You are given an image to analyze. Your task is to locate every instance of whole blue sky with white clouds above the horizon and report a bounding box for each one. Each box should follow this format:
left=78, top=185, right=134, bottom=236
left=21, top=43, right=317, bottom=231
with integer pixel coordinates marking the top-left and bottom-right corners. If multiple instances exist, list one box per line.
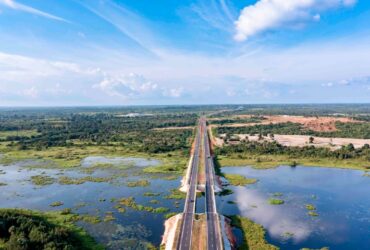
left=0, top=0, right=370, bottom=106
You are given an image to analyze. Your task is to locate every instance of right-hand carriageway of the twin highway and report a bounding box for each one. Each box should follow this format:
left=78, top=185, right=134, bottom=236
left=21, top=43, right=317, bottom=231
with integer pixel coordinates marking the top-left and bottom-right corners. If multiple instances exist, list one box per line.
left=201, top=119, right=223, bottom=250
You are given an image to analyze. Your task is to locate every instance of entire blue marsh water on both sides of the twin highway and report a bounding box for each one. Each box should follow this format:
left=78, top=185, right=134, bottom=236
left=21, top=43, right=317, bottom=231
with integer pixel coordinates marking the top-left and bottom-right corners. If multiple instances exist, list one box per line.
left=0, top=156, right=370, bottom=250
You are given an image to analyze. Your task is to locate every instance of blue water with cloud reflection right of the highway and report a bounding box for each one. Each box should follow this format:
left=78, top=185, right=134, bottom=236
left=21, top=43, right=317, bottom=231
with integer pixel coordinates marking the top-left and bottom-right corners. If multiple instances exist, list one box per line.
left=217, top=166, right=370, bottom=250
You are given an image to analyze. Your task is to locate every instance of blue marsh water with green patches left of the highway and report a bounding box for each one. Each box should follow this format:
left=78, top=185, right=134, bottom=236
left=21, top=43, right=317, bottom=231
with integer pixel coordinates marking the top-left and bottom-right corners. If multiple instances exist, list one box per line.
left=0, top=156, right=183, bottom=249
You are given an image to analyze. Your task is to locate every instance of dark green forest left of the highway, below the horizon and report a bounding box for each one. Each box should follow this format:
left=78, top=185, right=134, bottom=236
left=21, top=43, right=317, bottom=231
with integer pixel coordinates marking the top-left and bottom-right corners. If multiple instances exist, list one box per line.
left=0, top=113, right=198, bottom=153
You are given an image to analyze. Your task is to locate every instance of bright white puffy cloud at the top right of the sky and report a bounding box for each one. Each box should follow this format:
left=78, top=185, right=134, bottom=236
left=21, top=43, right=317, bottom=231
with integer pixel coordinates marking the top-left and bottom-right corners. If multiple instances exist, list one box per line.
left=234, top=0, right=357, bottom=41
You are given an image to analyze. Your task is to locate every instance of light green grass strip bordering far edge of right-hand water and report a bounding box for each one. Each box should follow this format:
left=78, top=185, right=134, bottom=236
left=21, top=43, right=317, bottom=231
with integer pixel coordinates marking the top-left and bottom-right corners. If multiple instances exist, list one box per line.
left=218, top=153, right=370, bottom=170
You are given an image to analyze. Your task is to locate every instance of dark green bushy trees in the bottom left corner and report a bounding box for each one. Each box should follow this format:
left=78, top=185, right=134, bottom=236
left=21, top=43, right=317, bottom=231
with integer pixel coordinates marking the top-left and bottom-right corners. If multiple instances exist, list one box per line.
left=0, top=209, right=104, bottom=250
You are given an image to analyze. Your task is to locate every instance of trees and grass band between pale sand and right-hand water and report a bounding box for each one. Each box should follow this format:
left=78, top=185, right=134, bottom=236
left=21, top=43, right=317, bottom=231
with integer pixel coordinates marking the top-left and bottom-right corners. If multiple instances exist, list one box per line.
left=215, top=142, right=370, bottom=170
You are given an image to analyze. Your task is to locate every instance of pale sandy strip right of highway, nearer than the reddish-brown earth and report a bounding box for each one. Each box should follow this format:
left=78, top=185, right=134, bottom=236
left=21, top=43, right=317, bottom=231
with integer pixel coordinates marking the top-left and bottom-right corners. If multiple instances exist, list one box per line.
left=221, top=134, right=370, bottom=149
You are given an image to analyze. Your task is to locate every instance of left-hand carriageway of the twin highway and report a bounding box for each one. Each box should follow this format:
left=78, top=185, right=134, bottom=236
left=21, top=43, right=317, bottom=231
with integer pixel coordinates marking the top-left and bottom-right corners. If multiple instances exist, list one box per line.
left=177, top=119, right=202, bottom=250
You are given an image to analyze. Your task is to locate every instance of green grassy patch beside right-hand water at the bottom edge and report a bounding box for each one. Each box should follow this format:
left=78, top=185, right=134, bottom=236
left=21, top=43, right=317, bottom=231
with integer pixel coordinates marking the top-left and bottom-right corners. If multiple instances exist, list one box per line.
left=229, top=215, right=279, bottom=250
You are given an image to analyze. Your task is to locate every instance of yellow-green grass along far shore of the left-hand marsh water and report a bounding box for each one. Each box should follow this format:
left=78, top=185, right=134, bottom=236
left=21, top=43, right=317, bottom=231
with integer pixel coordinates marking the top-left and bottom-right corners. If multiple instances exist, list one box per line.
left=0, top=142, right=188, bottom=175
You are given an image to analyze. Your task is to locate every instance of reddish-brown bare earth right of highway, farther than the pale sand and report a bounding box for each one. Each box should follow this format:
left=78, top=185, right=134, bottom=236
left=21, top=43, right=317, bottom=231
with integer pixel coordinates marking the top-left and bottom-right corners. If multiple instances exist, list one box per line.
left=213, top=115, right=360, bottom=132
